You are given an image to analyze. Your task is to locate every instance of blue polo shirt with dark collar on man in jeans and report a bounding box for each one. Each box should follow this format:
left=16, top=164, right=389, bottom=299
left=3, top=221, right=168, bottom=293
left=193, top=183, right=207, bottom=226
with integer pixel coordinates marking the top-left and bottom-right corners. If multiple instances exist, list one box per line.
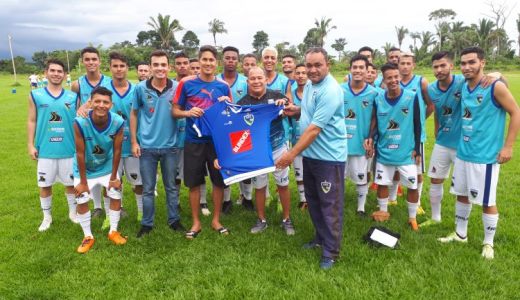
left=132, top=79, right=177, bottom=149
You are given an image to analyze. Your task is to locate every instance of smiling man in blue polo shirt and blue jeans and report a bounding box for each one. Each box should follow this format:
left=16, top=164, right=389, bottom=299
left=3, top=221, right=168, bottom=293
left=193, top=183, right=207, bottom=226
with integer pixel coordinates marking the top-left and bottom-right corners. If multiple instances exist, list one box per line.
left=130, top=50, right=185, bottom=238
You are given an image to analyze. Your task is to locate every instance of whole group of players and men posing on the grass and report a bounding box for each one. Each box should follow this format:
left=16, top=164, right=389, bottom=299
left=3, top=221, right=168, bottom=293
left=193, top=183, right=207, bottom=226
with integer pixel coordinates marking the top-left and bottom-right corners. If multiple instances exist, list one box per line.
left=28, top=41, right=520, bottom=269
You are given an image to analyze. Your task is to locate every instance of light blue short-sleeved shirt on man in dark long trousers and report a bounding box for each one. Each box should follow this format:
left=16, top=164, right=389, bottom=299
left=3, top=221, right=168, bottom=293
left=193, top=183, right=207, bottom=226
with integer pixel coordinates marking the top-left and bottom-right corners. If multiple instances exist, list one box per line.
left=300, top=74, right=347, bottom=162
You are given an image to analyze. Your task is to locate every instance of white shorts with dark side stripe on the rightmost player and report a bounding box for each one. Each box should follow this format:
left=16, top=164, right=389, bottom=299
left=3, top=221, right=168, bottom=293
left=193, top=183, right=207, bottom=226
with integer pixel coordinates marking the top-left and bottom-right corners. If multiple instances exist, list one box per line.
left=451, top=158, right=500, bottom=206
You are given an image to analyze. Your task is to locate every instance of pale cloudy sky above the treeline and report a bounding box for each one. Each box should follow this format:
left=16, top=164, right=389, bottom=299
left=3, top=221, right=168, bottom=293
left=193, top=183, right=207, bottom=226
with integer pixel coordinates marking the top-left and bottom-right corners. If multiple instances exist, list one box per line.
left=0, top=0, right=520, bottom=59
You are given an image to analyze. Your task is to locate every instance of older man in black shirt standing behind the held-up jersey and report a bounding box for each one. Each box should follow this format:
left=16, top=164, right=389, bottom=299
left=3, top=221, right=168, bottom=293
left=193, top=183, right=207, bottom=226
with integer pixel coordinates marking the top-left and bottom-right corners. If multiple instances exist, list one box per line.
left=237, top=67, right=295, bottom=235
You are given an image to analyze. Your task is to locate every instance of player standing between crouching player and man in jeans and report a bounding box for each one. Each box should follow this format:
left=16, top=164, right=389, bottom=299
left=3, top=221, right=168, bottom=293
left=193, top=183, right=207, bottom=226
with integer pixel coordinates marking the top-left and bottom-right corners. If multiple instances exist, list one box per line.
left=102, top=52, right=142, bottom=228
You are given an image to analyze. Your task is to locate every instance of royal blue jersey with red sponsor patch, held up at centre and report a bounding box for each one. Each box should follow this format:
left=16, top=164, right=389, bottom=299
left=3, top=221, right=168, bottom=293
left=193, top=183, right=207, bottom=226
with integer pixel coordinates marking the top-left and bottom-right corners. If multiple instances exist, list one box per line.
left=193, top=101, right=283, bottom=185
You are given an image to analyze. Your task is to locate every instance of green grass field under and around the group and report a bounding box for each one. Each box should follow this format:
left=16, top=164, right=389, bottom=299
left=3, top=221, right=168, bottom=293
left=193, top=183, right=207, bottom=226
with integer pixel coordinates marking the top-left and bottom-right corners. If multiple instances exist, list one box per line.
left=0, top=72, right=520, bottom=299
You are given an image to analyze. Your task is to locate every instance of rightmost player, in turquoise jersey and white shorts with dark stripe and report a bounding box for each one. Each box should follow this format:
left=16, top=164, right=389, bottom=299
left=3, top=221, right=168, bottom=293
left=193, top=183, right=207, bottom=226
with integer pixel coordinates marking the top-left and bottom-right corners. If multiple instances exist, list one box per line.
left=439, top=47, right=520, bottom=259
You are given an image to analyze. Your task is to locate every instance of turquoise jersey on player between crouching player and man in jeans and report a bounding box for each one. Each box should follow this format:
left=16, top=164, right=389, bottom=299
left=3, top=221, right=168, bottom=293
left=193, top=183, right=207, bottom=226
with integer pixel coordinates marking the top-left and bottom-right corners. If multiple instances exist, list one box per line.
left=108, top=81, right=135, bottom=157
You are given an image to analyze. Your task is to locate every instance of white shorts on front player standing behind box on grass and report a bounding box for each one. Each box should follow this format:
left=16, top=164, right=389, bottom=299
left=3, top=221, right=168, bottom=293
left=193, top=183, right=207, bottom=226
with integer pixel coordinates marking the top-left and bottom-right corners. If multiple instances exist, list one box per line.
left=374, top=162, right=417, bottom=190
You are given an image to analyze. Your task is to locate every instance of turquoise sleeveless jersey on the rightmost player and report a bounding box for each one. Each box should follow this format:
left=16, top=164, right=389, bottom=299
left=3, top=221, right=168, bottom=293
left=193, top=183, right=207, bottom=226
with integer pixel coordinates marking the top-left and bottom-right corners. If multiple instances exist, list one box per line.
left=457, top=82, right=506, bottom=164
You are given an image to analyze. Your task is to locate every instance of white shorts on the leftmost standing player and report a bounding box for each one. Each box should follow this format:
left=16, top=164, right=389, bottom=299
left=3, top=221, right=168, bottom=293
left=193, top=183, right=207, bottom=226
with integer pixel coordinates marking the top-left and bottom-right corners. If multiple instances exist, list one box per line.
left=36, top=157, right=74, bottom=187
